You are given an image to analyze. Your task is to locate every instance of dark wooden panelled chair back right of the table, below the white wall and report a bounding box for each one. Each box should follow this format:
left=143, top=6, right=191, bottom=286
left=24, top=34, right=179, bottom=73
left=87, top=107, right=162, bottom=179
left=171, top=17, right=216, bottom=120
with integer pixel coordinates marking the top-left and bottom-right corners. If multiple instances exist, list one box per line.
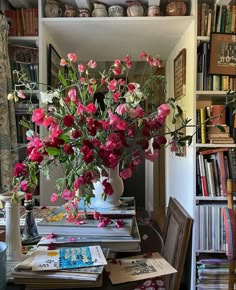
left=163, top=197, right=192, bottom=290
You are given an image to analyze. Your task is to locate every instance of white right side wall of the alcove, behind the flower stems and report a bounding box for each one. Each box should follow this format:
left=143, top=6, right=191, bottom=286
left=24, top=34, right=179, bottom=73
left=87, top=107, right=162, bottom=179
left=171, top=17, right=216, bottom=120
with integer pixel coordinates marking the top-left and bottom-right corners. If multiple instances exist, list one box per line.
left=166, top=23, right=195, bottom=216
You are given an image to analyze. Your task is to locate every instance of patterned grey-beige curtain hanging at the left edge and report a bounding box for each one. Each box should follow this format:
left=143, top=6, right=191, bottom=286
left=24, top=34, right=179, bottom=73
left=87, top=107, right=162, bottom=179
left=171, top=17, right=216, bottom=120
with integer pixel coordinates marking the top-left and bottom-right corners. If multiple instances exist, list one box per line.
left=0, top=14, right=18, bottom=192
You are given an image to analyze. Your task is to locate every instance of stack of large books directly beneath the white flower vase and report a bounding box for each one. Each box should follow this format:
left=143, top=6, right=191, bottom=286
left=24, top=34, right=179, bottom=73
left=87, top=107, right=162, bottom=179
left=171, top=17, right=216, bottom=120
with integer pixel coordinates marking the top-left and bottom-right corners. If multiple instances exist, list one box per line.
left=37, top=197, right=141, bottom=253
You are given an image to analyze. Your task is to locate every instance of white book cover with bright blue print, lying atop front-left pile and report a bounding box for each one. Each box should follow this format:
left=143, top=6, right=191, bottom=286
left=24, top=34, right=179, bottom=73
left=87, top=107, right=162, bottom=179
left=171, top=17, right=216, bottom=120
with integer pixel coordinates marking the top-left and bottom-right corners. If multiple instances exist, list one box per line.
left=32, top=246, right=107, bottom=271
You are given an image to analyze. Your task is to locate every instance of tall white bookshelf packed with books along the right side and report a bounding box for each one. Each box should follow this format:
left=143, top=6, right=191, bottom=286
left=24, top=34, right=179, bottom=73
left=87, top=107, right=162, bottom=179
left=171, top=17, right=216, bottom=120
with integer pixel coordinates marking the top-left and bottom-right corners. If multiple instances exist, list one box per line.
left=193, top=1, right=236, bottom=289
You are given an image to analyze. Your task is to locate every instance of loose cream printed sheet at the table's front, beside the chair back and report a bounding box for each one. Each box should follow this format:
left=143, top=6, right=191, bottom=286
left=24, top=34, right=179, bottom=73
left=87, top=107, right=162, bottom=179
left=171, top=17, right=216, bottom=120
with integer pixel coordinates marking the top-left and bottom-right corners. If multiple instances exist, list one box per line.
left=105, top=252, right=177, bottom=284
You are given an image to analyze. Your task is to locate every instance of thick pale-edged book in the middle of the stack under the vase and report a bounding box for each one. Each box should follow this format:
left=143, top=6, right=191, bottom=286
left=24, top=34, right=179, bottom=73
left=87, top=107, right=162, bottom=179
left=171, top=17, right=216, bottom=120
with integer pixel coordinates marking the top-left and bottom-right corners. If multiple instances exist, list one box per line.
left=37, top=211, right=134, bottom=236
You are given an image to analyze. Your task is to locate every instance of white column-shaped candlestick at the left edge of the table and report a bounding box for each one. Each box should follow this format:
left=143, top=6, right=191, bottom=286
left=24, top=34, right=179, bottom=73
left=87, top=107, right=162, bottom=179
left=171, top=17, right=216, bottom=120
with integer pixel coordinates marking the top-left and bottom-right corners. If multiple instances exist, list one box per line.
left=0, top=192, right=24, bottom=262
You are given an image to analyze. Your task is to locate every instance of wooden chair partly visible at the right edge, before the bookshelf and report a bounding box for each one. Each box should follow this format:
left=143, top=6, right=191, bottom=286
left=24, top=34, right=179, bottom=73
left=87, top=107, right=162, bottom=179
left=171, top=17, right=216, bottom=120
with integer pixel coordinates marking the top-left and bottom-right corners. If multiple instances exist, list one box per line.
left=223, top=179, right=236, bottom=290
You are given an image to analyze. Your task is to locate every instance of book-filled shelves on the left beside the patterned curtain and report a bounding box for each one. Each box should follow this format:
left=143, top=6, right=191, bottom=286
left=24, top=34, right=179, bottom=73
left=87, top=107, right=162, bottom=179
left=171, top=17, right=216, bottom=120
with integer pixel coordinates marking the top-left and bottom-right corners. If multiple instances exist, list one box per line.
left=0, top=1, right=39, bottom=199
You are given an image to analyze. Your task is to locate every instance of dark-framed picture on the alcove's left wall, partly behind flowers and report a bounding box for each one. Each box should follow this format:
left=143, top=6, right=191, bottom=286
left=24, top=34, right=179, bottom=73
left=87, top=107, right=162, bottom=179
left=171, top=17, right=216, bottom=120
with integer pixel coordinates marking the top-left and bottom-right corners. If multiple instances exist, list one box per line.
left=48, top=44, right=61, bottom=90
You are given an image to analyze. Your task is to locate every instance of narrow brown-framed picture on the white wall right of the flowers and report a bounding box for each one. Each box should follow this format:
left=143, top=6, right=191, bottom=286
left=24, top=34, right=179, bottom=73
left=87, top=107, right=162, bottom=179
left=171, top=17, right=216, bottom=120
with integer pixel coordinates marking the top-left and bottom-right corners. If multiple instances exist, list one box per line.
left=174, top=48, right=186, bottom=99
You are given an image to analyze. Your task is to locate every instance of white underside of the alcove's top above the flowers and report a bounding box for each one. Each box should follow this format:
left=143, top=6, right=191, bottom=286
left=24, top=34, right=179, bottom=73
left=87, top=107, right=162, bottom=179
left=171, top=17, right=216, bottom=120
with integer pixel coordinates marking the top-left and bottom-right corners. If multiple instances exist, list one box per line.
left=42, top=16, right=194, bottom=61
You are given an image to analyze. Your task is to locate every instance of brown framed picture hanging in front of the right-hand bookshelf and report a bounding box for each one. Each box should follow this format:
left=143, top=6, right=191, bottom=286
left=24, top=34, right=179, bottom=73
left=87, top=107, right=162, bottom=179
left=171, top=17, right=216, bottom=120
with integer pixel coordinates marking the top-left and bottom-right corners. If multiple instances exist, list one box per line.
left=209, top=32, right=236, bottom=75
